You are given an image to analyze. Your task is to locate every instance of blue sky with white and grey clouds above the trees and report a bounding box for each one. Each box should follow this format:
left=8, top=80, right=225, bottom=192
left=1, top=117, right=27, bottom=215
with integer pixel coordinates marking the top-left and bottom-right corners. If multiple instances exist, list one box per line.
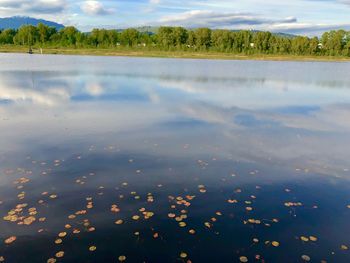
left=0, top=0, right=350, bottom=36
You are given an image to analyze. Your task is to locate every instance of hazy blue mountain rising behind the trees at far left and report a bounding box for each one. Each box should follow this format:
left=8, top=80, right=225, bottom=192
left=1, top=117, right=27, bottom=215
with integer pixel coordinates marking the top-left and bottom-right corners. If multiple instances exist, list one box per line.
left=0, top=16, right=64, bottom=30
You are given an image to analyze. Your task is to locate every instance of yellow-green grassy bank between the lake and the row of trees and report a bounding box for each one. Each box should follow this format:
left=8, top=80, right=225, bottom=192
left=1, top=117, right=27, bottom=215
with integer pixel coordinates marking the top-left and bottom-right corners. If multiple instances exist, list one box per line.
left=0, top=45, right=350, bottom=62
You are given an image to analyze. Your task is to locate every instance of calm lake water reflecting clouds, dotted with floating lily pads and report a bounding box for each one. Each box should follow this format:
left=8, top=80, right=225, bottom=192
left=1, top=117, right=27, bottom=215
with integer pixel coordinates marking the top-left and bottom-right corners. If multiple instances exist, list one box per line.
left=0, top=55, right=350, bottom=263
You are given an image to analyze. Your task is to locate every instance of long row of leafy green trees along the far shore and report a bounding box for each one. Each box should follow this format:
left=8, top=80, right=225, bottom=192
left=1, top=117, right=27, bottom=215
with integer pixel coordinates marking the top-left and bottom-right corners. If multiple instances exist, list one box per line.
left=0, top=24, right=350, bottom=56
